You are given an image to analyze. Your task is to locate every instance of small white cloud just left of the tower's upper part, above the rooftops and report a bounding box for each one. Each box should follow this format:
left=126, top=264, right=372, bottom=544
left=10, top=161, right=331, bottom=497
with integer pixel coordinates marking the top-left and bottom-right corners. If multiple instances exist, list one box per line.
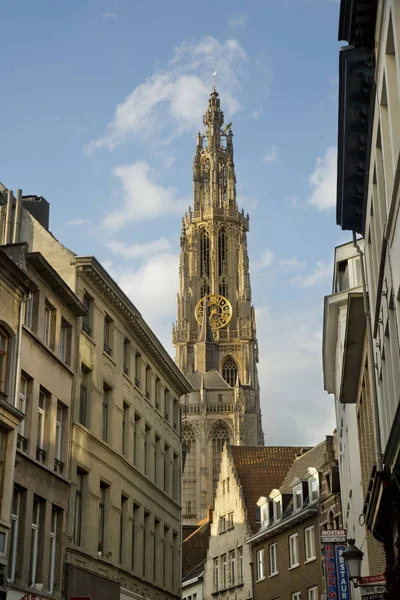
left=102, top=161, right=190, bottom=231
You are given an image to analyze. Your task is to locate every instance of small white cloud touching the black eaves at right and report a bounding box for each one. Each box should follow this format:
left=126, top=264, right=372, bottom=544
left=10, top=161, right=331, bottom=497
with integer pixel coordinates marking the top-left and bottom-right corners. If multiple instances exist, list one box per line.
left=309, top=146, right=337, bottom=211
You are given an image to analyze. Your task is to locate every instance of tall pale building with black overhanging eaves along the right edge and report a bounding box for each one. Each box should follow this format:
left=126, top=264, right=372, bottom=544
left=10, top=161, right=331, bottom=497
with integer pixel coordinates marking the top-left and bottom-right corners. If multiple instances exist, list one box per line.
left=337, top=0, right=400, bottom=598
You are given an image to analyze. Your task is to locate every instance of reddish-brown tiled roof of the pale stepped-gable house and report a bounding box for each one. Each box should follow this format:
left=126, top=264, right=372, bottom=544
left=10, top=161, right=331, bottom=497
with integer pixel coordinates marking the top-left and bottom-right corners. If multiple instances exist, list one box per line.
left=229, top=446, right=302, bottom=533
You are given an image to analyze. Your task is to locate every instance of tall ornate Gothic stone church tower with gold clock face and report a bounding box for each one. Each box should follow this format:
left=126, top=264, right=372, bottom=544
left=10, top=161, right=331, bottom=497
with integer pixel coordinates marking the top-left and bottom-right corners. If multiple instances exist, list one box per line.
left=173, top=88, right=264, bottom=524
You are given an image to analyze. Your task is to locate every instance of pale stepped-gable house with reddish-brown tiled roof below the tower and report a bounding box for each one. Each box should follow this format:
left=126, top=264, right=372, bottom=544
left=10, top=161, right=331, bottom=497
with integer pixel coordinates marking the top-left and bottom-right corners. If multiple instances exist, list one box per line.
left=204, top=446, right=302, bottom=600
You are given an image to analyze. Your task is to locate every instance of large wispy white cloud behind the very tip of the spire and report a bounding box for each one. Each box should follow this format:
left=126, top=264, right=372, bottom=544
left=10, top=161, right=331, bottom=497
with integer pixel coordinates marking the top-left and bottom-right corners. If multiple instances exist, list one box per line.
left=87, top=36, right=246, bottom=152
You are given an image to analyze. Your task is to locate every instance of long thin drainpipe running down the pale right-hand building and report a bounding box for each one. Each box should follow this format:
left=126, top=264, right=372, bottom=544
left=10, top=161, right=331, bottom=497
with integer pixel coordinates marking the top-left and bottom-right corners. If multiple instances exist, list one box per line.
left=353, top=231, right=382, bottom=471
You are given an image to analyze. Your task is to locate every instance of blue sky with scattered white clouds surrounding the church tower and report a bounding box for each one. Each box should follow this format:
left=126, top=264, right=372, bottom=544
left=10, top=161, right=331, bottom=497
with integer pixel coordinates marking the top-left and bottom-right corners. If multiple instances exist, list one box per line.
left=0, top=0, right=349, bottom=444
